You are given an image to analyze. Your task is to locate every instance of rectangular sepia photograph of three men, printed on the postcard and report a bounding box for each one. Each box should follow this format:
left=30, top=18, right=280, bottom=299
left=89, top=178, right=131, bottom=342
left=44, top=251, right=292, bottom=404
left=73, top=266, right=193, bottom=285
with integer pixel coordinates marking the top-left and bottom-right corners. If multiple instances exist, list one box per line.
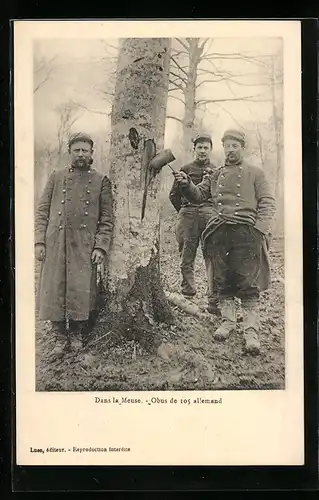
left=32, top=33, right=286, bottom=392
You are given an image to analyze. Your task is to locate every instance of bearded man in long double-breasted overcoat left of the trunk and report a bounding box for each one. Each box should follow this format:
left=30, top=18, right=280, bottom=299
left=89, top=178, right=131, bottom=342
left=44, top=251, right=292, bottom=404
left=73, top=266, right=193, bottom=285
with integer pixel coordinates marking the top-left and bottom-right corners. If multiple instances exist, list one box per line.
left=35, top=133, right=113, bottom=356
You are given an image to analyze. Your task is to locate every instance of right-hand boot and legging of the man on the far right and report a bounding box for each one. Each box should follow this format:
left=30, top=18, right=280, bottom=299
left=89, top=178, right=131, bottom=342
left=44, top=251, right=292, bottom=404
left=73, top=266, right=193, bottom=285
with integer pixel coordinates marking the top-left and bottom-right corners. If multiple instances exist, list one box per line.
left=242, top=301, right=260, bottom=354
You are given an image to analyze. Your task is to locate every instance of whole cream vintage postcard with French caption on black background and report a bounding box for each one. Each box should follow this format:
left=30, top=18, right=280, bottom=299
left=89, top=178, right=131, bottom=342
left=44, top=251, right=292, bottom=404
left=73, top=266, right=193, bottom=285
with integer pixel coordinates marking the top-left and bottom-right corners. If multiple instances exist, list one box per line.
left=14, top=21, right=304, bottom=466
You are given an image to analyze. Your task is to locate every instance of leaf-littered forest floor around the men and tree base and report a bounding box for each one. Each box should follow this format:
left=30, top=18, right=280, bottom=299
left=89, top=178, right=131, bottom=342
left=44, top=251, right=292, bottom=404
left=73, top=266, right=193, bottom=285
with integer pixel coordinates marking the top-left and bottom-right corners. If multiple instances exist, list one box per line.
left=36, top=206, right=285, bottom=391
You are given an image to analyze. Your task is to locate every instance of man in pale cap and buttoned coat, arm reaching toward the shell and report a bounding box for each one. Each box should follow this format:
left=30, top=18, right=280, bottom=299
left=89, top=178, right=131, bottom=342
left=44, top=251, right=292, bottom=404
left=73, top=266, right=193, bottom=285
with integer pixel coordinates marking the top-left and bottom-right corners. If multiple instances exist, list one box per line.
left=175, top=130, right=275, bottom=354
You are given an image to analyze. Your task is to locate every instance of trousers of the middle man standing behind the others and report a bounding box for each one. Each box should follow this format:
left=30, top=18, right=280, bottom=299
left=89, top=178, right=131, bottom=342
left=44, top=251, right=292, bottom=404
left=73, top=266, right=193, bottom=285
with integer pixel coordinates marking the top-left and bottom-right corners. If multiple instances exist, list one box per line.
left=176, top=206, right=218, bottom=297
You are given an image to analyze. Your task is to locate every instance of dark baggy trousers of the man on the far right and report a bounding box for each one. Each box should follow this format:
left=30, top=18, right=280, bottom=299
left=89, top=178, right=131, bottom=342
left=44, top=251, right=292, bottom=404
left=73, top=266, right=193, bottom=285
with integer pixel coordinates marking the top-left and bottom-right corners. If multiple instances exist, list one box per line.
left=207, top=224, right=262, bottom=300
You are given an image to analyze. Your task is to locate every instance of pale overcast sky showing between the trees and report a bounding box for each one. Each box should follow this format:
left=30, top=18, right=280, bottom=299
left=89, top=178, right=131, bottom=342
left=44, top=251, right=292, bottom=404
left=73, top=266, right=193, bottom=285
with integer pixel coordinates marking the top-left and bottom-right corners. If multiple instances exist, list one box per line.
left=34, top=38, right=281, bottom=155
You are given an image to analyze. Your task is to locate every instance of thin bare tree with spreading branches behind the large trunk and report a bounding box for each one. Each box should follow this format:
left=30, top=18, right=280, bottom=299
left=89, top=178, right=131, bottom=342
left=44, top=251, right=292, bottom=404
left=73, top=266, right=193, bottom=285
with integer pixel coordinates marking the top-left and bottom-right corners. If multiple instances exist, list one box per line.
left=168, top=38, right=276, bottom=161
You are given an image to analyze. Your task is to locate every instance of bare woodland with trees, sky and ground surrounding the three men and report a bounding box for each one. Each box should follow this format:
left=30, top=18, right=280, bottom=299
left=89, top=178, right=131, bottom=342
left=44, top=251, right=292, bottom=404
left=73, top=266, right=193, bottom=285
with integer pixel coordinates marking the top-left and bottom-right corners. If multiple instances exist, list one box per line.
left=33, top=38, right=285, bottom=391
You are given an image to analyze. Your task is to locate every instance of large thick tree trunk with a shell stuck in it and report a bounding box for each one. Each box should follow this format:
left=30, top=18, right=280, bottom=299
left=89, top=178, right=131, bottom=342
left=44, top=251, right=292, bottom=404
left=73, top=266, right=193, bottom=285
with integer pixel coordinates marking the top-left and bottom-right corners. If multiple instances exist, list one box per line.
left=105, top=38, right=172, bottom=350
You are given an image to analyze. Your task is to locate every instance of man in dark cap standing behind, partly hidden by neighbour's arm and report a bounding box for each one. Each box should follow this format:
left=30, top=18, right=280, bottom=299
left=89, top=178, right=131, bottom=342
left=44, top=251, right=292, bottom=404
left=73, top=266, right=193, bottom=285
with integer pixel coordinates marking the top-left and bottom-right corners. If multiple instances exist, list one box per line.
left=169, top=134, right=218, bottom=313
